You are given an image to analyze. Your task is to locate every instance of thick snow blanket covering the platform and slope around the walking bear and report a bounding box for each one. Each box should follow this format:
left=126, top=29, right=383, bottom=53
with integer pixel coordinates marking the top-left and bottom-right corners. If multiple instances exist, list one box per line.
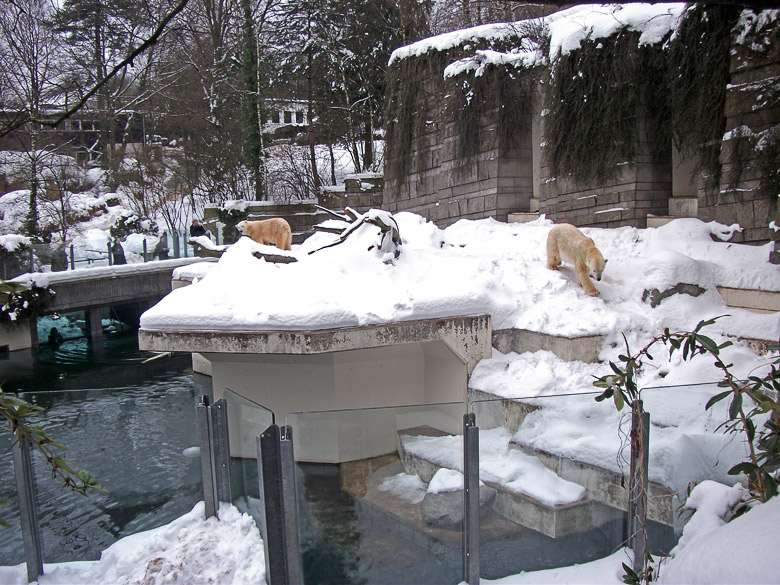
left=141, top=213, right=780, bottom=340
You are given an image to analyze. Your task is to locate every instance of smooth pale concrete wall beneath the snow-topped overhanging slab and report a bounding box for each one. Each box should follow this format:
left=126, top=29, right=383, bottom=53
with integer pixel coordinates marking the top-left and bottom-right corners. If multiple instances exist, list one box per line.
left=204, top=341, right=468, bottom=463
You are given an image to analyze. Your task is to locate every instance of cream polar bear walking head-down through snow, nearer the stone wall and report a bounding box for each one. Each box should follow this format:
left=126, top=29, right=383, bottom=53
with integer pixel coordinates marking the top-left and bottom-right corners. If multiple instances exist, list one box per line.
left=547, top=223, right=607, bottom=297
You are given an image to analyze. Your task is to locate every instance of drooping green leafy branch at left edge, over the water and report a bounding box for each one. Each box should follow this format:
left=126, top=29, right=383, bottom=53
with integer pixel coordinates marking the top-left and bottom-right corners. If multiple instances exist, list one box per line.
left=0, top=390, right=100, bottom=526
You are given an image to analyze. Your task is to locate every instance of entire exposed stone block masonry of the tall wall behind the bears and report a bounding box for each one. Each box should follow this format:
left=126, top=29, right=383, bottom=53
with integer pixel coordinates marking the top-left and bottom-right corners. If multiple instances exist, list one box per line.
left=383, top=17, right=780, bottom=242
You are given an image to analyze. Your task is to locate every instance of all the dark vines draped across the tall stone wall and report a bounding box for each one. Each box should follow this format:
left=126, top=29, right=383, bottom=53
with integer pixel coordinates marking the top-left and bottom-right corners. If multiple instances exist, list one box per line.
left=386, top=4, right=780, bottom=203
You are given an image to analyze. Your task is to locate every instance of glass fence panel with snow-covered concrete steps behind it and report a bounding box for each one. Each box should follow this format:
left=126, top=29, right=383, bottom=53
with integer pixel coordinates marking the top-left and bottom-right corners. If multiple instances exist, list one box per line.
left=469, top=394, right=630, bottom=579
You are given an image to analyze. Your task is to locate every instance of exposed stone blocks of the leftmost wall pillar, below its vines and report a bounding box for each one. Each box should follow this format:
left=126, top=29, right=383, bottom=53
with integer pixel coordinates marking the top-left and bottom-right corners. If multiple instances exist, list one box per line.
left=383, top=69, right=533, bottom=227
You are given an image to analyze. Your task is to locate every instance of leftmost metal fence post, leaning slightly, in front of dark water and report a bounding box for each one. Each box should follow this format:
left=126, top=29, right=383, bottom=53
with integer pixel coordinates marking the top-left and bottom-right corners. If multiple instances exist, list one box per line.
left=13, top=426, right=43, bottom=582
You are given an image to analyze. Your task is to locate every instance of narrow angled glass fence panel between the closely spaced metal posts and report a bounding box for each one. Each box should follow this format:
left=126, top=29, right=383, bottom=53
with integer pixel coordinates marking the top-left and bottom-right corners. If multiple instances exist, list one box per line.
left=223, top=388, right=274, bottom=522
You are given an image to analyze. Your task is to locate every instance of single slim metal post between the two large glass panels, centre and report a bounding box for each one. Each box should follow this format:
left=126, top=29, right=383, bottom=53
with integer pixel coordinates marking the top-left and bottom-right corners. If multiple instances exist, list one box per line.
left=463, top=413, right=479, bottom=585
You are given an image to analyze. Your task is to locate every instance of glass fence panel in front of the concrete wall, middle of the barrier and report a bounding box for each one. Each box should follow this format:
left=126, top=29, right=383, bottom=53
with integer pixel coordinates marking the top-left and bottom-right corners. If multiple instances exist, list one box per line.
left=287, top=403, right=466, bottom=585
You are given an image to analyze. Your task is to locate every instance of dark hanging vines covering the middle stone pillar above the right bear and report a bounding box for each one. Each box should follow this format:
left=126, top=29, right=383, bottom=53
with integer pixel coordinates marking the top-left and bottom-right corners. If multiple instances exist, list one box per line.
left=545, top=30, right=668, bottom=183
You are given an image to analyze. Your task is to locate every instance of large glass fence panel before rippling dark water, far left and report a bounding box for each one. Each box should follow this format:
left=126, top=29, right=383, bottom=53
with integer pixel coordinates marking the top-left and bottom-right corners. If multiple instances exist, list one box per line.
left=0, top=387, right=203, bottom=563
